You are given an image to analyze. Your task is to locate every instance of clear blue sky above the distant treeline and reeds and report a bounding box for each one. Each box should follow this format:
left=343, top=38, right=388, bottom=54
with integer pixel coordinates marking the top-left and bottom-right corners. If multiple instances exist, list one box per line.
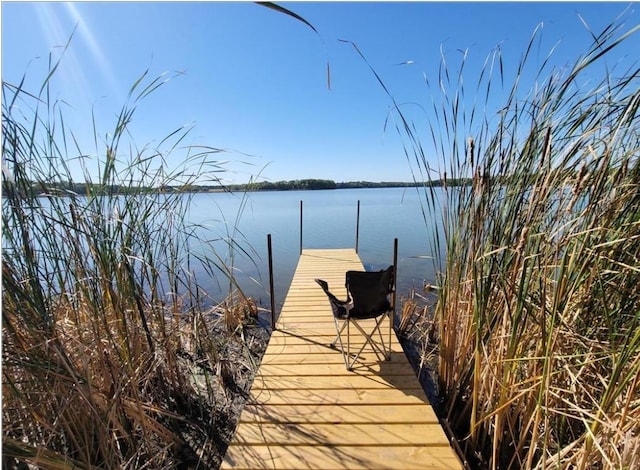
left=2, top=2, right=640, bottom=183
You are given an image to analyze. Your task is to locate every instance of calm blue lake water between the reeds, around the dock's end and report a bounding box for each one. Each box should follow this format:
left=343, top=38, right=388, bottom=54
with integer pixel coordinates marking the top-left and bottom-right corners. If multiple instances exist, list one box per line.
left=187, top=188, right=436, bottom=309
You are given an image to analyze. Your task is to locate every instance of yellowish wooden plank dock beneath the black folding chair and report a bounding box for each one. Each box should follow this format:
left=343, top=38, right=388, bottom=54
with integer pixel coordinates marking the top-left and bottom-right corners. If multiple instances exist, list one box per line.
left=221, top=249, right=462, bottom=470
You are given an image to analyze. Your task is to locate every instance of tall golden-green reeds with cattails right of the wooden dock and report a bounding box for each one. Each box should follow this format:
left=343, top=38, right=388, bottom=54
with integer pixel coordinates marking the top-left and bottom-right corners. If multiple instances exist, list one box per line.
left=378, top=13, right=640, bottom=469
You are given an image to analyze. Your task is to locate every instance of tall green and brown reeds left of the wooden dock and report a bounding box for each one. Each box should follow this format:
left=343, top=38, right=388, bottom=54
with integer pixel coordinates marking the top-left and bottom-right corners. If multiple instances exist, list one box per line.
left=2, top=46, right=255, bottom=469
